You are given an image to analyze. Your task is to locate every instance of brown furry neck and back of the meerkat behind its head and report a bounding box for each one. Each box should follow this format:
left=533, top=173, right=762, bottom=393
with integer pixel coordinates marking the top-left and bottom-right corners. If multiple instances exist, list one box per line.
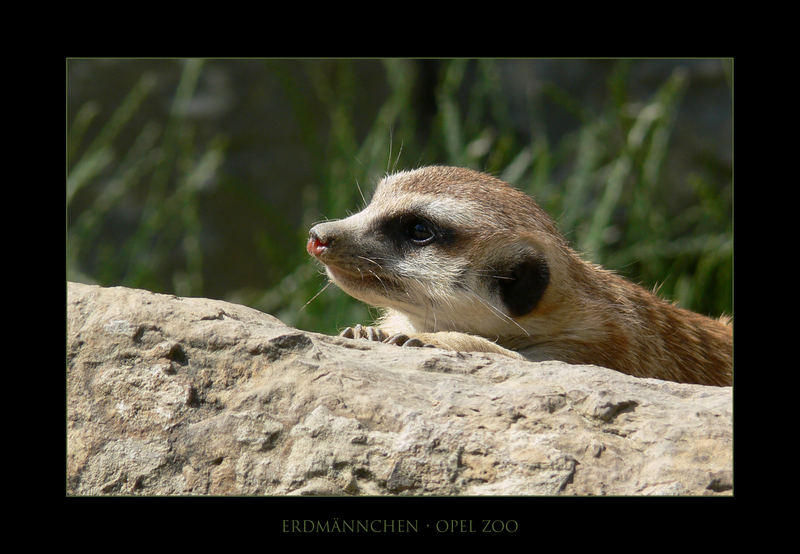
left=516, top=254, right=733, bottom=385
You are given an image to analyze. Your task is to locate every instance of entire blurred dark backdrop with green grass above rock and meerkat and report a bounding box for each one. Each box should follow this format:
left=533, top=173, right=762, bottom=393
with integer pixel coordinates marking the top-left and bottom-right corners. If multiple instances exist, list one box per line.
left=66, top=59, right=733, bottom=333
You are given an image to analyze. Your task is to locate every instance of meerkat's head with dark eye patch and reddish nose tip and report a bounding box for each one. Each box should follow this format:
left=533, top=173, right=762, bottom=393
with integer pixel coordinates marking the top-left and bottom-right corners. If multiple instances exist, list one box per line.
left=307, top=166, right=560, bottom=336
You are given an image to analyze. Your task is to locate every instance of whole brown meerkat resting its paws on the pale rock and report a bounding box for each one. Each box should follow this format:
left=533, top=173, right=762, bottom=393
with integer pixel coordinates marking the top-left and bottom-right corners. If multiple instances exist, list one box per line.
left=306, top=166, right=733, bottom=386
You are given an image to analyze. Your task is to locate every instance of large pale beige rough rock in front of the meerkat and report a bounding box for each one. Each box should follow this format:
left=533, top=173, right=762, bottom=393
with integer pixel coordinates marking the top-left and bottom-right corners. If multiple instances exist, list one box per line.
left=67, top=283, right=733, bottom=496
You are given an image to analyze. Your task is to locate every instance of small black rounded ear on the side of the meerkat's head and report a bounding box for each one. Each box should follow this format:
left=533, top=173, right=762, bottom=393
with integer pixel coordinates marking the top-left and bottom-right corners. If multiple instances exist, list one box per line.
left=496, top=254, right=550, bottom=317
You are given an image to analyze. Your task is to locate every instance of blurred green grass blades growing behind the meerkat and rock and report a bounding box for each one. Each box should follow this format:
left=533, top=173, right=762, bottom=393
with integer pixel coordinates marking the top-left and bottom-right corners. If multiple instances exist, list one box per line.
left=67, top=59, right=733, bottom=332
